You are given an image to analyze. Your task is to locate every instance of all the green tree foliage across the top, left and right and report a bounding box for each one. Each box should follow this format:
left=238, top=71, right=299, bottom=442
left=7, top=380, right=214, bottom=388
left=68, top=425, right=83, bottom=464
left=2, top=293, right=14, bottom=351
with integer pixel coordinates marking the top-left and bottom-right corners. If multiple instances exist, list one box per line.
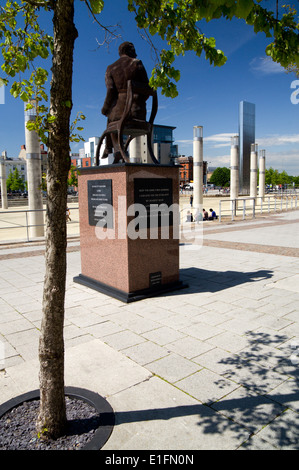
left=0, top=0, right=299, bottom=115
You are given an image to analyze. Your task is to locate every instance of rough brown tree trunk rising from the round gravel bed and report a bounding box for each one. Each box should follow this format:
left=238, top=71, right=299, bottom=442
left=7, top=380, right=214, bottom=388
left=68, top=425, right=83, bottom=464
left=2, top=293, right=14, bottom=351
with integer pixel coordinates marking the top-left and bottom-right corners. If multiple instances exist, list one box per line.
left=37, top=0, right=77, bottom=438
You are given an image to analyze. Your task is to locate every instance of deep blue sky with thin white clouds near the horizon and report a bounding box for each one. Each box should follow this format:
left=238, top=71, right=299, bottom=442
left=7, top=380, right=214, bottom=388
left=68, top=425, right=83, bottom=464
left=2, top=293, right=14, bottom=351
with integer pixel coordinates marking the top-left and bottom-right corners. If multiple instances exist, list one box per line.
left=0, top=0, right=299, bottom=175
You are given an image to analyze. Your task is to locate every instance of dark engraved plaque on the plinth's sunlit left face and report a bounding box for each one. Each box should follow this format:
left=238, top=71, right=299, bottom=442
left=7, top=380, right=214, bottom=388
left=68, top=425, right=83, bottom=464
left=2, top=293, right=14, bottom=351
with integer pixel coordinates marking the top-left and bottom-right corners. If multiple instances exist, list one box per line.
left=87, top=180, right=113, bottom=228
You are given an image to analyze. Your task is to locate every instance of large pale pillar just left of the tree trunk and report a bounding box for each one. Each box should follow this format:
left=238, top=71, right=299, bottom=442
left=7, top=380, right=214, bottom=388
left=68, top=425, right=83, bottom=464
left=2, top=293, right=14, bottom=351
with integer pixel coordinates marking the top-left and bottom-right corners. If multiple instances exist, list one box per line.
left=25, top=103, right=44, bottom=237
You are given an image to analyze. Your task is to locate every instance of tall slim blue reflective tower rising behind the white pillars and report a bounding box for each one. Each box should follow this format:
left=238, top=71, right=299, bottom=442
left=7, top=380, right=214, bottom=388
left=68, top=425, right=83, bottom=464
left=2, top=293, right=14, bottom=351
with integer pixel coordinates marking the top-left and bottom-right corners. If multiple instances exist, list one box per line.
left=239, top=101, right=255, bottom=194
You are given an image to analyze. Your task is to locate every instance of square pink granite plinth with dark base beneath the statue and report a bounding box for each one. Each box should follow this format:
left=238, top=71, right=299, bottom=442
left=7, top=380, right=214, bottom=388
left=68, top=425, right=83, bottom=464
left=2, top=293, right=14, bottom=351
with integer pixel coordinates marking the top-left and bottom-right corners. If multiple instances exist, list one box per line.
left=74, top=163, right=184, bottom=302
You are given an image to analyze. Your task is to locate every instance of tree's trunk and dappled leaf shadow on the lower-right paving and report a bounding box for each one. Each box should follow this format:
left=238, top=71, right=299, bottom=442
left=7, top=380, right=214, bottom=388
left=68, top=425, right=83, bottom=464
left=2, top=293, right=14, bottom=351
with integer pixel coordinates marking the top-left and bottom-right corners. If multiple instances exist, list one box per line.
left=115, top=331, right=299, bottom=450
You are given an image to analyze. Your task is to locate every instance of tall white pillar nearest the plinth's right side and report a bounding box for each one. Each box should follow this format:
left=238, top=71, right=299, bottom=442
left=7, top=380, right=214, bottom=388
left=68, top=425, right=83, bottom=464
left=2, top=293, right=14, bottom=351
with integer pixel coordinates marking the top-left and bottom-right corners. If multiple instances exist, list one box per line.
left=193, top=126, right=203, bottom=212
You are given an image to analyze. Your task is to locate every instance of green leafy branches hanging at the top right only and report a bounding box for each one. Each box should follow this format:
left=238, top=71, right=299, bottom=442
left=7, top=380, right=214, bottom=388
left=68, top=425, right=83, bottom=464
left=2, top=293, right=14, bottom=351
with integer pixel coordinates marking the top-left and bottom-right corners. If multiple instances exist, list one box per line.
left=128, top=0, right=299, bottom=97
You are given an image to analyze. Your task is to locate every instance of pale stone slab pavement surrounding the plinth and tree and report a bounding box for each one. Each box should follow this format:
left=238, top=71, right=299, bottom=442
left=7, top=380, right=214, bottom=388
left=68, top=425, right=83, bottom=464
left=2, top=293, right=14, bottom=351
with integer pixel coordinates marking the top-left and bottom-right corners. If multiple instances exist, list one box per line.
left=0, top=211, right=299, bottom=450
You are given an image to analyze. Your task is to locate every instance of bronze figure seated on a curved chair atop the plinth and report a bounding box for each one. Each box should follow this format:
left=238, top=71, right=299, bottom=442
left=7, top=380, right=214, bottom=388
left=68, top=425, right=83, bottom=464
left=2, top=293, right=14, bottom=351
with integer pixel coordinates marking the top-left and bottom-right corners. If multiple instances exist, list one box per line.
left=96, top=42, right=159, bottom=165
